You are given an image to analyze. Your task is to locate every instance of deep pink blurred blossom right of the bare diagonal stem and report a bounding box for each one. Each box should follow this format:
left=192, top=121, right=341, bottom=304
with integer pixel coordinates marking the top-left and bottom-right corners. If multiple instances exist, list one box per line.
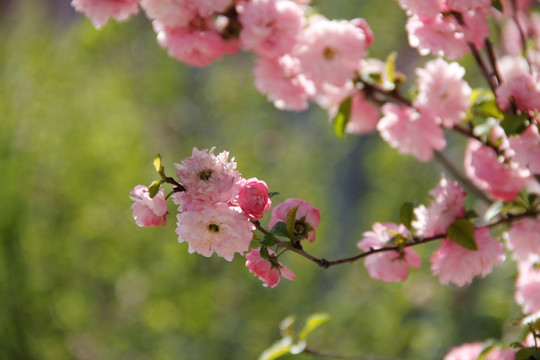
left=465, top=139, right=529, bottom=201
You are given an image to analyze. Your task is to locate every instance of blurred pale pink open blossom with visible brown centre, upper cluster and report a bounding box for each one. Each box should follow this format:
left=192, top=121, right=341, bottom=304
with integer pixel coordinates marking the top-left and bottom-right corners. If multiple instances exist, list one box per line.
left=293, top=17, right=368, bottom=89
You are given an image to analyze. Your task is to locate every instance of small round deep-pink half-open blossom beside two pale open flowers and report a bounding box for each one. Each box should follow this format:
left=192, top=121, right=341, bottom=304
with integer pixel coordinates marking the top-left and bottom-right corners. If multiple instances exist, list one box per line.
left=238, top=178, right=272, bottom=220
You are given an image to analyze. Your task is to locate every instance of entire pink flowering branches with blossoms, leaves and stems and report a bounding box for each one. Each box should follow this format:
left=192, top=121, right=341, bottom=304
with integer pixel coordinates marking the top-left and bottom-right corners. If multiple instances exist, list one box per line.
left=72, top=0, right=540, bottom=360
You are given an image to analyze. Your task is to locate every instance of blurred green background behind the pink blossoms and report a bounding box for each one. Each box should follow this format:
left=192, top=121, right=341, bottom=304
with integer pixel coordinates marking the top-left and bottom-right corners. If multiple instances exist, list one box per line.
left=0, top=0, right=519, bottom=360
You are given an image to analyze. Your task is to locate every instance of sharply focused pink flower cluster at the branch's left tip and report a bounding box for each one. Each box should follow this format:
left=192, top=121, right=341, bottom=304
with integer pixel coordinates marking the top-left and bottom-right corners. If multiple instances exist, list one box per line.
left=130, top=148, right=320, bottom=287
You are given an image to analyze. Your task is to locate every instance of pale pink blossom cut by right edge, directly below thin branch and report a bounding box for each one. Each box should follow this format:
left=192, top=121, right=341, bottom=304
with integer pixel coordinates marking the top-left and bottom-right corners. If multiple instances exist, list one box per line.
left=506, top=218, right=540, bottom=261
